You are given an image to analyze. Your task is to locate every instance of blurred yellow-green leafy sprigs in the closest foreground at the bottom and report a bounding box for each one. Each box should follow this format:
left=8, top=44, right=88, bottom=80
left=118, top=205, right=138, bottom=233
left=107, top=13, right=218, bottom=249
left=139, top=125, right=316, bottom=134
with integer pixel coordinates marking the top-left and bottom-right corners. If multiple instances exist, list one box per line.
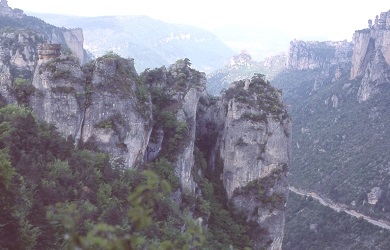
left=49, top=171, right=205, bottom=250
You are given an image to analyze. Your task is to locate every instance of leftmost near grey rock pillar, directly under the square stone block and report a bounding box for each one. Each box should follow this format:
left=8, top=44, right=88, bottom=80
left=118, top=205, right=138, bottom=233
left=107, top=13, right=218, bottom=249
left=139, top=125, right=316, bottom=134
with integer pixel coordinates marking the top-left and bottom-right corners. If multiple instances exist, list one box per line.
left=30, top=57, right=85, bottom=138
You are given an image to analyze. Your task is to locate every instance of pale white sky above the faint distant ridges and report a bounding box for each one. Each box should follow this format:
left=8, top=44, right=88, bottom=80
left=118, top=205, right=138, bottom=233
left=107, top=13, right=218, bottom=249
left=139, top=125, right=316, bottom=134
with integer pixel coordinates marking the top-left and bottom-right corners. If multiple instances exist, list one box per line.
left=8, top=0, right=390, bottom=41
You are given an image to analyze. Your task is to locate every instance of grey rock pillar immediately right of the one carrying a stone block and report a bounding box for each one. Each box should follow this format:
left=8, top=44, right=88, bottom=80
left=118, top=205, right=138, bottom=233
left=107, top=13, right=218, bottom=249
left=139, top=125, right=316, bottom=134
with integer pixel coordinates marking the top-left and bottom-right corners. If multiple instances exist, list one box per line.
left=81, top=56, right=152, bottom=167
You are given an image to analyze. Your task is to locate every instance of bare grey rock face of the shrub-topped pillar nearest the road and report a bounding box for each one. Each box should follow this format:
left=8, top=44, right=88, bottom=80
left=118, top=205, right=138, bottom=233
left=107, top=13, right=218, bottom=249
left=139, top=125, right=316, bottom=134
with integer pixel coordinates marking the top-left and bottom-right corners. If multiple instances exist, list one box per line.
left=220, top=83, right=291, bottom=249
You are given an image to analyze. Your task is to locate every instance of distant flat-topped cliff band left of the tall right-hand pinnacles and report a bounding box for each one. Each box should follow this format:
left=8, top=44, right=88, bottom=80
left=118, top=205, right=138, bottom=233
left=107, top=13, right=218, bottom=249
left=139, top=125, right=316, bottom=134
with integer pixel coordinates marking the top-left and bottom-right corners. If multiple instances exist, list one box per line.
left=287, top=40, right=353, bottom=70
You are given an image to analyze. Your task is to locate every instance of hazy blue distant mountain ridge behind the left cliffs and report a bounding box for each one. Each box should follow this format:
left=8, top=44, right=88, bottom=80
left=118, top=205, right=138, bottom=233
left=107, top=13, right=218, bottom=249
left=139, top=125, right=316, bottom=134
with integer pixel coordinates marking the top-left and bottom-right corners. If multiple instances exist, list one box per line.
left=31, top=13, right=235, bottom=72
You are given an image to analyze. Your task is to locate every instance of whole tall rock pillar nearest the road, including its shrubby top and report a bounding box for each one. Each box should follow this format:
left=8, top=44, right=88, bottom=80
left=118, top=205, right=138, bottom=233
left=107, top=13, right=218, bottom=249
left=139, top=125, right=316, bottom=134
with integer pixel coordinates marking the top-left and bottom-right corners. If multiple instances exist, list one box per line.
left=199, top=76, right=291, bottom=249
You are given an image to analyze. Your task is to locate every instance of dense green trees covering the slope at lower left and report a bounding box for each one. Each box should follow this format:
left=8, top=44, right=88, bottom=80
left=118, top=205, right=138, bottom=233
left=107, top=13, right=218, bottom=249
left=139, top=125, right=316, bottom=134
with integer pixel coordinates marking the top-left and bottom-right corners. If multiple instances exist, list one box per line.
left=0, top=106, right=208, bottom=249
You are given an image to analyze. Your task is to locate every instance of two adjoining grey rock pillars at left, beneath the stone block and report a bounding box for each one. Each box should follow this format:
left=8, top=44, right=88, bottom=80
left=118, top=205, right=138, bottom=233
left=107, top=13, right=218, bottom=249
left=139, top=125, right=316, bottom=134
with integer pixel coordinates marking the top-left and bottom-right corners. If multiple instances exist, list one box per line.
left=31, top=56, right=152, bottom=167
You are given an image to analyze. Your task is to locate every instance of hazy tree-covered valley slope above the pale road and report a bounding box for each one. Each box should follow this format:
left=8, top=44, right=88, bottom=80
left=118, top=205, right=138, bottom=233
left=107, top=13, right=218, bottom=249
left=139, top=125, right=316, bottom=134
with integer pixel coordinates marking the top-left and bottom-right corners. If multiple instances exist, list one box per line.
left=273, top=65, right=390, bottom=223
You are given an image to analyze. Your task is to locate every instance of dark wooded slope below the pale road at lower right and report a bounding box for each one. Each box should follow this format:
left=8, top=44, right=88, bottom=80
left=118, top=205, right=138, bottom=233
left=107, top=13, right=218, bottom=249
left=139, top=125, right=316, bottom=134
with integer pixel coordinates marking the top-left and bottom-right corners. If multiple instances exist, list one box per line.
left=283, top=192, right=390, bottom=250
